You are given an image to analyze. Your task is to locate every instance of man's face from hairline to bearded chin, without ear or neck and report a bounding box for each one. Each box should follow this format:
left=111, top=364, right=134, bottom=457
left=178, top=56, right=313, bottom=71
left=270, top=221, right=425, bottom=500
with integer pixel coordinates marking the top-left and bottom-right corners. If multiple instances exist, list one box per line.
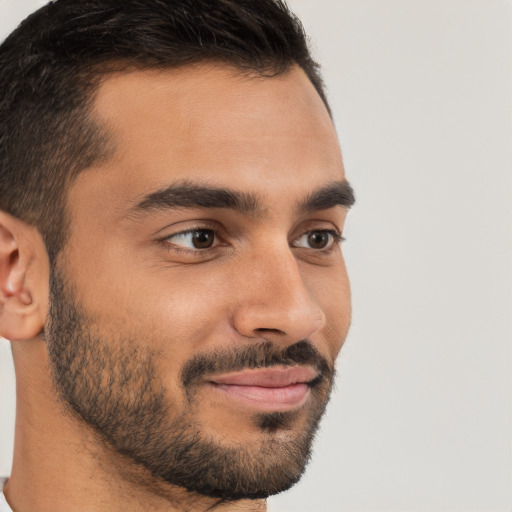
left=46, top=65, right=350, bottom=498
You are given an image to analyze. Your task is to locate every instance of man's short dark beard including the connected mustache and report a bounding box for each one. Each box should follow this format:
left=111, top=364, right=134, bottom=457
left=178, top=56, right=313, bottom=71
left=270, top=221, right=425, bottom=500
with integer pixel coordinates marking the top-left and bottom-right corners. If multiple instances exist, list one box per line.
left=44, top=270, right=334, bottom=500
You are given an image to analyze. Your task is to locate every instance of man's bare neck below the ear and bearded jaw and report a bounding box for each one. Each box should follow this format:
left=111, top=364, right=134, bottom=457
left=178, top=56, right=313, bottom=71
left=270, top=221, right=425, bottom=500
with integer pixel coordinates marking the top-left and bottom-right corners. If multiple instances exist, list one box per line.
left=4, top=339, right=266, bottom=512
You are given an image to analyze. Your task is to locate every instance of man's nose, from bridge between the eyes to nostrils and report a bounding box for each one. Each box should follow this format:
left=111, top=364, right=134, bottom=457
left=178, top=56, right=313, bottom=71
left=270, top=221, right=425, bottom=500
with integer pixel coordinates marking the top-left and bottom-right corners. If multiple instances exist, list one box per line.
left=233, top=247, right=326, bottom=344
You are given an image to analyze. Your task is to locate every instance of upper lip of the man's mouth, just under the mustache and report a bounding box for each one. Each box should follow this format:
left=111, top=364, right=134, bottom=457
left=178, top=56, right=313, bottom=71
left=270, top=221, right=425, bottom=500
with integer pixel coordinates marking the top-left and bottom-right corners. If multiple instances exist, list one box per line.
left=209, top=366, right=318, bottom=388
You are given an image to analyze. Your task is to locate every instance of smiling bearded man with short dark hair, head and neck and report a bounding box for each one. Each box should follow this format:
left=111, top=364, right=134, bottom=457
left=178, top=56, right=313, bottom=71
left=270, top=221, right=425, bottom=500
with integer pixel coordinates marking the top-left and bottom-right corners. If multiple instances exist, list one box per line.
left=0, top=0, right=354, bottom=512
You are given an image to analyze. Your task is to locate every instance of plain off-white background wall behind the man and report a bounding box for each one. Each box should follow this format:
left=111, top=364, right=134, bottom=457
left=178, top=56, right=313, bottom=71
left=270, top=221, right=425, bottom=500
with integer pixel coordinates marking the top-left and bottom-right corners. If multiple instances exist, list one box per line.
left=0, top=0, right=512, bottom=512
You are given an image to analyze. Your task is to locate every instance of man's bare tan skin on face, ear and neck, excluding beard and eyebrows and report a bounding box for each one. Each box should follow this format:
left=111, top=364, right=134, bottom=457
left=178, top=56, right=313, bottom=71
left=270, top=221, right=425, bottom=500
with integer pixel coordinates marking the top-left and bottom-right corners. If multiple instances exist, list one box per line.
left=0, top=64, right=351, bottom=512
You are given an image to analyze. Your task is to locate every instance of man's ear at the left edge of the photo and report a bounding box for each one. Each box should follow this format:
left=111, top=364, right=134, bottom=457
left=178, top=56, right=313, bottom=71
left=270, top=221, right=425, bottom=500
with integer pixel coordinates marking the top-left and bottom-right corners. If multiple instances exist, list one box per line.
left=0, top=211, right=50, bottom=341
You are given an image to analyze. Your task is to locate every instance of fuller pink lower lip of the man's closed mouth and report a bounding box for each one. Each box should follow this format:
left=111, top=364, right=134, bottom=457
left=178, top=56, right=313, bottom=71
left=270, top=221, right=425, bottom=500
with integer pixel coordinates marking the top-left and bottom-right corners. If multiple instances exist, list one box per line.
left=207, top=383, right=309, bottom=411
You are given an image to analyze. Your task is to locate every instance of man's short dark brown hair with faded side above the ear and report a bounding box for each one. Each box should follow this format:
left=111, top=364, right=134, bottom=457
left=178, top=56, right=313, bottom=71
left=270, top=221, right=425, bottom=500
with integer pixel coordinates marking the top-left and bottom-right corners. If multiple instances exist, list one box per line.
left=0, top=0, right=330, bottom=262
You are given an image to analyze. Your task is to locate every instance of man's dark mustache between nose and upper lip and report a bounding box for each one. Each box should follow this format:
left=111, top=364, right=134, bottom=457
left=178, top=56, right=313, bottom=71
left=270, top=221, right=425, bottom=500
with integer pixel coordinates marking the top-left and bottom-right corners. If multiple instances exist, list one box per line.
left=181, top=340, right=335, bottom=389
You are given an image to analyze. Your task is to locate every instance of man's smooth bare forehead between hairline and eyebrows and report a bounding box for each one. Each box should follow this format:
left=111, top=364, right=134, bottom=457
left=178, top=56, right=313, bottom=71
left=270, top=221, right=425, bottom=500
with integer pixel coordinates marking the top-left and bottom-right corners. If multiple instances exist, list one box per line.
left=70, top=64, right=343, bottom=216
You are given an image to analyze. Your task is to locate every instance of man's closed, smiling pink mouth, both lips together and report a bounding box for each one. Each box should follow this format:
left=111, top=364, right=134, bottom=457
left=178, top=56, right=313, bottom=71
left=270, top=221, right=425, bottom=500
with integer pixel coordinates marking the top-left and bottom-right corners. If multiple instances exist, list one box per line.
left=208, top=366, right=319, bottom=412
